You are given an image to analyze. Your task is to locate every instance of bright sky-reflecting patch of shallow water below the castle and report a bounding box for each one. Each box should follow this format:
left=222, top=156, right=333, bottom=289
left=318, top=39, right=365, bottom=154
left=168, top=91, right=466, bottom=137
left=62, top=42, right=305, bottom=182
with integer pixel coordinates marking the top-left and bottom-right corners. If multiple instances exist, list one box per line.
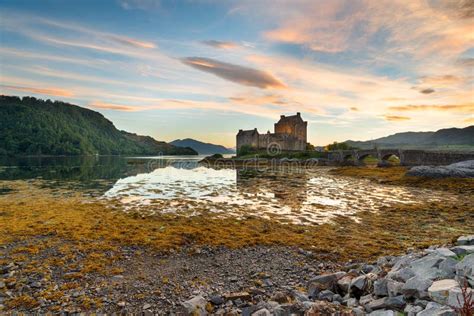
left=104, top=166, right=455, bottom=224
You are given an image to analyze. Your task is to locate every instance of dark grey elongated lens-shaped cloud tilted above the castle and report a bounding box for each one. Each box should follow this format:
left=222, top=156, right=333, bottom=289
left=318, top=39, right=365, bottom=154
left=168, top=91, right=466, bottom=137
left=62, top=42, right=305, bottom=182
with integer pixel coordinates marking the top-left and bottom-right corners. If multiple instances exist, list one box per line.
left=181, top=57, right=286, bottom=89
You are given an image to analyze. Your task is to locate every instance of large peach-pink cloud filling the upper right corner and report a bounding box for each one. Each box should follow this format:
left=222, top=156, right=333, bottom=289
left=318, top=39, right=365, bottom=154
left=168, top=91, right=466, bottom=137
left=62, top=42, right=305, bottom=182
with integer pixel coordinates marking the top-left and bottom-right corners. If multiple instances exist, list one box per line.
left=239, top=0, right=474, bottom=59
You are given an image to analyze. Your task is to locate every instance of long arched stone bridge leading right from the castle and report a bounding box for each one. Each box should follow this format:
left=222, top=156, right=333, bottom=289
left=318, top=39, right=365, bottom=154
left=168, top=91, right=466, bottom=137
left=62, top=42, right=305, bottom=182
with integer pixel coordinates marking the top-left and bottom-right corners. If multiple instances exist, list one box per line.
left=328, top=149, right=474, bottom=166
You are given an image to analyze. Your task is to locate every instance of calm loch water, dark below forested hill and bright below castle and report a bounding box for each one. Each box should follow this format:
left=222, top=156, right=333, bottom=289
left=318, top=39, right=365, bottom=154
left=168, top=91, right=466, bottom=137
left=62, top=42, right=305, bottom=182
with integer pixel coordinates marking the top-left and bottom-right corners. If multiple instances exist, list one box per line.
left=0, top=156, right=458, bottom=224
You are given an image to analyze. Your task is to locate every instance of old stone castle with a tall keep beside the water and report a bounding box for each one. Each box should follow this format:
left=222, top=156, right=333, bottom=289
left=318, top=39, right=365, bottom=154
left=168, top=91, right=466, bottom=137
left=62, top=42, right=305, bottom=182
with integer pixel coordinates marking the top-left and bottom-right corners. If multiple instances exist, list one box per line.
left=237, top=112, right=308, bottom=152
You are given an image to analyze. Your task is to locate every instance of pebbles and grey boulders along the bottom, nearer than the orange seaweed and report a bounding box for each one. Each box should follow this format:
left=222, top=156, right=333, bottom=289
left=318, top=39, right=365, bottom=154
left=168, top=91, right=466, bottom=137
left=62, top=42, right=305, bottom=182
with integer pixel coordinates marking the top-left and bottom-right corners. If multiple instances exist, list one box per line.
left=0, top=236, right=474, bottom=316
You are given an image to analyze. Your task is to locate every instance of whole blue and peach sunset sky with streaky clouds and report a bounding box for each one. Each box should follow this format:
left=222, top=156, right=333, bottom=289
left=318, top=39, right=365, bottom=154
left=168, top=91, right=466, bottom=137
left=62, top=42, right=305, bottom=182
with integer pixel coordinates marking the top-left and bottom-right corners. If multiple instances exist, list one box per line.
left=0, top=0, right=474, bottom=147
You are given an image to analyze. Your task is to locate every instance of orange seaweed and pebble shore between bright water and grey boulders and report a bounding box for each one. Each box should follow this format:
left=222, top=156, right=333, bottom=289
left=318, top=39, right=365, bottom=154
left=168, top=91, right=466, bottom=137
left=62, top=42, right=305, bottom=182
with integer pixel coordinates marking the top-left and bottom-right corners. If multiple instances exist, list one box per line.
left=0, top=168, right=474, bottom=315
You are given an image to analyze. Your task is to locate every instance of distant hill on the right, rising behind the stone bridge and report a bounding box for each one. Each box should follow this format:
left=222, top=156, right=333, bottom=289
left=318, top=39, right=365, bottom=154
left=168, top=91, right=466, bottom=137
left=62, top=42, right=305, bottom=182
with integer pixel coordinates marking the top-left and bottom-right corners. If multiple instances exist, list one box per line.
left=345, top=125, right=474, bottom=149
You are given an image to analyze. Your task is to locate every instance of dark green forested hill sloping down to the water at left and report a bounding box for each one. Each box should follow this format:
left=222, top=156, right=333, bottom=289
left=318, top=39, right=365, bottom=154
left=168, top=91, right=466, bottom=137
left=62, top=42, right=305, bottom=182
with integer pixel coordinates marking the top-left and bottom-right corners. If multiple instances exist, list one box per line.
left=0, top=96, right=197, bottom=155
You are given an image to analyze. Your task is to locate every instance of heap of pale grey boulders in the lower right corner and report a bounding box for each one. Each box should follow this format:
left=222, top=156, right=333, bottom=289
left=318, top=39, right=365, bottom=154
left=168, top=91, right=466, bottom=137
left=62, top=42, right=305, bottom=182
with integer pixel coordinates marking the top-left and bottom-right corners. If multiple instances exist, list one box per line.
left=176, top=235, right=474, bottom=316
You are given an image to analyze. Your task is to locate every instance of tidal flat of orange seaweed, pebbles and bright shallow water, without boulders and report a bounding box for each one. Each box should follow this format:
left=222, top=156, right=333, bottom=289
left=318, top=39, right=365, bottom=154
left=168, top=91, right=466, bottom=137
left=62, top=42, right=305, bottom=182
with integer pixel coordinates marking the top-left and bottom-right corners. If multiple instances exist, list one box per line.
left=0, top=157, right=474, bottom=312
